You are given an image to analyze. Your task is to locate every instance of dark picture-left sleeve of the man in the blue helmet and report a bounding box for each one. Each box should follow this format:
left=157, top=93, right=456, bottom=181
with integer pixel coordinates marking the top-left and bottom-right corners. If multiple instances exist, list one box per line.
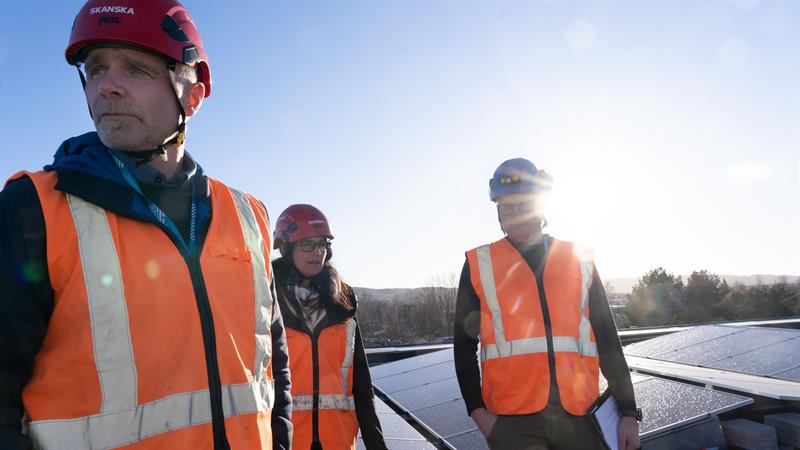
left=453, top=261, right=484, bottom=414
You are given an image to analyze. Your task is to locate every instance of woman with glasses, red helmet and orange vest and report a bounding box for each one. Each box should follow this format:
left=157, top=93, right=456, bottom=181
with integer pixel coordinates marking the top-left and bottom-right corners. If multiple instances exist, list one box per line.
left=272, top=204, right=386, bottom=450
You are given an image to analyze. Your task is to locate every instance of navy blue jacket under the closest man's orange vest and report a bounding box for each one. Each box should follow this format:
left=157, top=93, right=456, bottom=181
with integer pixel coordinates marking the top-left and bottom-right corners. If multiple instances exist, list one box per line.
left=0, top=132, right=292, bottom=450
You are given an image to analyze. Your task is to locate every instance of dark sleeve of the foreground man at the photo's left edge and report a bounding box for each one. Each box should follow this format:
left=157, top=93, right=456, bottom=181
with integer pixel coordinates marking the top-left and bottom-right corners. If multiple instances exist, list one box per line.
left=0, top=177, right=53, bottom=450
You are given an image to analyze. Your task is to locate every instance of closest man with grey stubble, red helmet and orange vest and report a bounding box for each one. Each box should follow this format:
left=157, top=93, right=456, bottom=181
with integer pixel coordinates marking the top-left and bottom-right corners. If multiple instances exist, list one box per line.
left=0, top=0, right=291, bottom=450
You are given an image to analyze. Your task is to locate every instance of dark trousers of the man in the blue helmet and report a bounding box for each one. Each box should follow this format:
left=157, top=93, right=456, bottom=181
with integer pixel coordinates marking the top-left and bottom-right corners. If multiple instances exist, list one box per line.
left=486, top=406, right=605, bottom=450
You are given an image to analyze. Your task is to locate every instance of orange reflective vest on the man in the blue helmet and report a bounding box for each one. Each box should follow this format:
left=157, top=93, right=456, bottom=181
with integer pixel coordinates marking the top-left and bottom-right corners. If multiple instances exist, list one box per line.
left=467, top=239, right=599, bottom=415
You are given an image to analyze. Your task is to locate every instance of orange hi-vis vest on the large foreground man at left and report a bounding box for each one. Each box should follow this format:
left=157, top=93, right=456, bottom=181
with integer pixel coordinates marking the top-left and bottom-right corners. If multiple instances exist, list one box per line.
left=15, top=172, right=275, bottom=450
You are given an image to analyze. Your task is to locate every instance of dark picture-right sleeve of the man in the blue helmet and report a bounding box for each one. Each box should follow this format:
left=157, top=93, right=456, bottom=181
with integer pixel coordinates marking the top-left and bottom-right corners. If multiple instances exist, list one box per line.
left=589, top=268, right=636, bottom=411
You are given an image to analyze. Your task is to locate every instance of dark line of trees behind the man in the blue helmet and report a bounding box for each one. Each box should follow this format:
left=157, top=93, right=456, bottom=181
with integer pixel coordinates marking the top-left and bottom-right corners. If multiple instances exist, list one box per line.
left=358, top=267, right=800, bottom=347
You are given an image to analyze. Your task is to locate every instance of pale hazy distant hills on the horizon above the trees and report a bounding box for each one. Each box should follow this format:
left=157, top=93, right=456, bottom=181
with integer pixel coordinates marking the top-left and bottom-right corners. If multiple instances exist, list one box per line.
left=353, top=275, right=800, bottom=302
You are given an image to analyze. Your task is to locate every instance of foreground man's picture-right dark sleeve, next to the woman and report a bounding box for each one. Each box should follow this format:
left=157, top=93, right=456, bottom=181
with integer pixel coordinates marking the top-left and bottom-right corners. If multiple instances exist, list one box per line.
left=270, top=278, right=292, bottom=450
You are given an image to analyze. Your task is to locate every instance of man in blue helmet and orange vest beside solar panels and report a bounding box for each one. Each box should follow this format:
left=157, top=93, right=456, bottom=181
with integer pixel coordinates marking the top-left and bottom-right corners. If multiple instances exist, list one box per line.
left=453, top=158, right=641, bottom=450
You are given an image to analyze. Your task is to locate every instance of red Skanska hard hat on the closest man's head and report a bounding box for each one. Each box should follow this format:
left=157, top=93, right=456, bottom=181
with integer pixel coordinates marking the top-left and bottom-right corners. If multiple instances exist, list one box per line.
left=64, top=0, right=211, bottom=97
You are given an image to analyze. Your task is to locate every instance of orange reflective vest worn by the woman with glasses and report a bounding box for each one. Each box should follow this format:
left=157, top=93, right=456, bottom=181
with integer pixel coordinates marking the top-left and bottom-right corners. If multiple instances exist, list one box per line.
left=286, top=318, right=358, bottom=450
